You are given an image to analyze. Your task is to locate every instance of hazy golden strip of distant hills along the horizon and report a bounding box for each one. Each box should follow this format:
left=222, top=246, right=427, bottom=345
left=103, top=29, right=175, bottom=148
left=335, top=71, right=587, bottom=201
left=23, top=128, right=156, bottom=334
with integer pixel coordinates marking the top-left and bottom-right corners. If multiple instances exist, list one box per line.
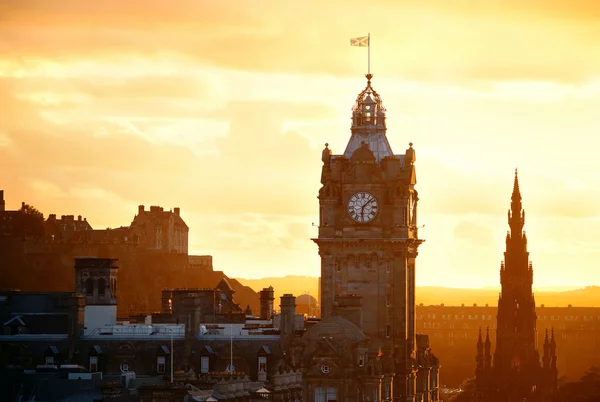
left=238, top=276, right=600, bottom=308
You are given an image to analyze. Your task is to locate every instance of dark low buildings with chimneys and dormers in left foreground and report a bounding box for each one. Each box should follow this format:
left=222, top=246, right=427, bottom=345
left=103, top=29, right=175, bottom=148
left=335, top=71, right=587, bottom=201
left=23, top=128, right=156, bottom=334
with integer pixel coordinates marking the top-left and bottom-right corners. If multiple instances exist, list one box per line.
left=0, top=257, right=304, bottom=401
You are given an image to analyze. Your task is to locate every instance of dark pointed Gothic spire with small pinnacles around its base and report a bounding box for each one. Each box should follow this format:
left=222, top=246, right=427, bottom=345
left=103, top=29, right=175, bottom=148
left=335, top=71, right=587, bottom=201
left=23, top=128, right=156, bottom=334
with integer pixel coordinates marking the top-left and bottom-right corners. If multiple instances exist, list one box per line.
left=476, top=171, right=557, bottom=402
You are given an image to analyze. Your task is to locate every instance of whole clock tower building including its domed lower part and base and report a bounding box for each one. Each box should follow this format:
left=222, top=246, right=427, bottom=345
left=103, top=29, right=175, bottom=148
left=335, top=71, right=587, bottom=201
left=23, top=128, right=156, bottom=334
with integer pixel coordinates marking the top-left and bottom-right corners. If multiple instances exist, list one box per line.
left=312, top=74, right=439, bottom=401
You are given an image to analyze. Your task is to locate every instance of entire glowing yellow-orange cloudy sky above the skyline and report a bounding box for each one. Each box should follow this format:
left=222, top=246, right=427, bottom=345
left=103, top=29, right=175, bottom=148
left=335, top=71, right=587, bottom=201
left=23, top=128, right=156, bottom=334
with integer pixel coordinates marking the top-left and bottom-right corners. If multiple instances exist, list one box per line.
left=0, top=0, right=600, bottom=287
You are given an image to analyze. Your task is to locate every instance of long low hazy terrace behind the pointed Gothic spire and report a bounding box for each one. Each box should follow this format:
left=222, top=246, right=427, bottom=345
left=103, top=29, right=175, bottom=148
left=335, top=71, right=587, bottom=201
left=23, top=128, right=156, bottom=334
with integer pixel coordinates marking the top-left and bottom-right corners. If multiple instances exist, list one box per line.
left=416, top=304, right=600, bottom=388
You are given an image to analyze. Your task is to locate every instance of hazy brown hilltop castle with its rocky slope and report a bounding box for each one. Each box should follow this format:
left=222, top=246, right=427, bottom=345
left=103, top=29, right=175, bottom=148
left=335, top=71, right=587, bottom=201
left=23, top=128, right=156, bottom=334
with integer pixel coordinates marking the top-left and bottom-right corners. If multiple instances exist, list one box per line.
left=0, top=198, right=259, bottom=317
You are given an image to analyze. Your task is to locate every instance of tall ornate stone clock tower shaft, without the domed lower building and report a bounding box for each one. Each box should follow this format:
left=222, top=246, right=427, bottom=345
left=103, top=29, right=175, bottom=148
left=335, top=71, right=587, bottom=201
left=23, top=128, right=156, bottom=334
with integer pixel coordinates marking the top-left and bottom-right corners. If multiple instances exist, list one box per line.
left=313, top=74, right=428, bottom=401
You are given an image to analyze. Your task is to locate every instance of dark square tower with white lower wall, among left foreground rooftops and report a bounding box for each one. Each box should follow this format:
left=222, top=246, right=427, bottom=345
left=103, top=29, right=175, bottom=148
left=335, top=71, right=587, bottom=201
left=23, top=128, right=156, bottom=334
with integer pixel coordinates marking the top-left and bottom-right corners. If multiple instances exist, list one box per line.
left=75, top=257, right=119, bottom=335
